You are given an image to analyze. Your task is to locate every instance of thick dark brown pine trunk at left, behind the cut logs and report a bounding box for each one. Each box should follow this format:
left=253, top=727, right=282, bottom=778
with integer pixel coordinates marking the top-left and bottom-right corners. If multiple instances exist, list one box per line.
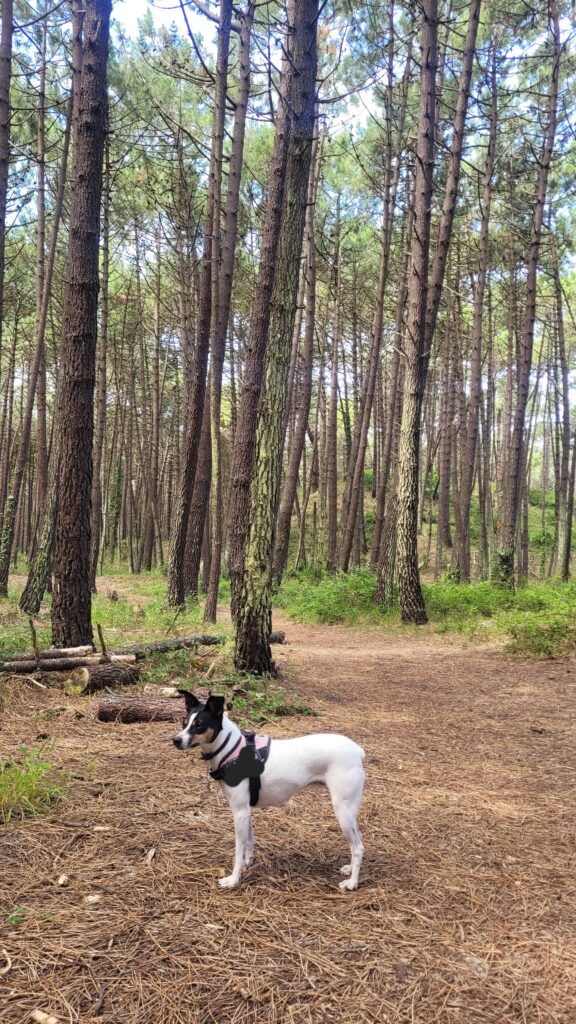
left=52, top=0, right=112, bottom=646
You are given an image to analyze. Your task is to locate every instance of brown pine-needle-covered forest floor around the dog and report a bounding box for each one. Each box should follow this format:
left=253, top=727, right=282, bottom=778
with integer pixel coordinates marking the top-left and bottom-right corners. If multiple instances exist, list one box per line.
left=0, top=593, right=576, bottom=1024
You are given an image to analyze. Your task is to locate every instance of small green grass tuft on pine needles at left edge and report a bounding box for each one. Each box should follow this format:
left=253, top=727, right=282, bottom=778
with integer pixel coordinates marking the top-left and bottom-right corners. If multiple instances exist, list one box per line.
left=0, top=748, right=67, bottom=824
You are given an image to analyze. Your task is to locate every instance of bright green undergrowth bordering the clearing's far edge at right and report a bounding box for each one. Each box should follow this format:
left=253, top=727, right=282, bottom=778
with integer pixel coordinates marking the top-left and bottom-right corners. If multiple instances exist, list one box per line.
left=276, top=569, right=576, bottom=656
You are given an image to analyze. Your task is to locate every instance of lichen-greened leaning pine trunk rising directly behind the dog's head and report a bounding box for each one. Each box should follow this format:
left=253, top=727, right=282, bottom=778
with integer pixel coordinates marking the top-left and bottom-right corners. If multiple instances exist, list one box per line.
left=235, top=0, right=318, bottom=675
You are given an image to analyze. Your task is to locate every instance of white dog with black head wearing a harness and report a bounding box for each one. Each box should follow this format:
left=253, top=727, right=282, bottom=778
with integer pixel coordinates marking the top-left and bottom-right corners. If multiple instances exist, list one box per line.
left=172, top=690, right=365, bottom=890
